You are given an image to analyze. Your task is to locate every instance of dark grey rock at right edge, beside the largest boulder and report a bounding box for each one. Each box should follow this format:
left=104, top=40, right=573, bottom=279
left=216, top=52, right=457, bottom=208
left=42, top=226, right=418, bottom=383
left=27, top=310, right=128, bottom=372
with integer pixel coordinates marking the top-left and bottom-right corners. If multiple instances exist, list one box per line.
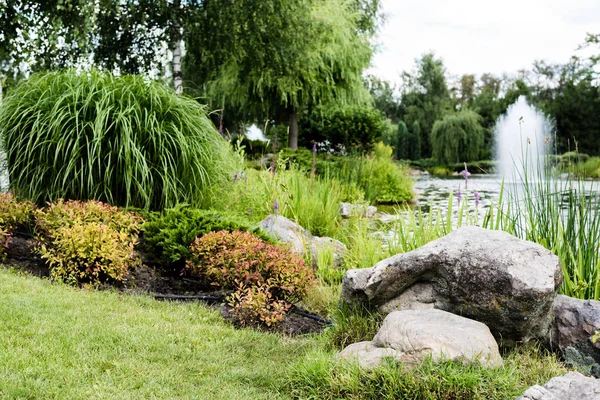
left=550, top=295, right=600, bottom=377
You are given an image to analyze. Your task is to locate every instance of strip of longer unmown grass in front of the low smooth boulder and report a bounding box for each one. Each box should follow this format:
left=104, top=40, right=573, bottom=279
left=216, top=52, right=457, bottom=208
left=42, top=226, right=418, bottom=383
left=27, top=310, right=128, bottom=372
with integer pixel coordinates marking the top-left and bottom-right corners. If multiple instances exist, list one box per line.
left=289, top=347, right=566, bottom=400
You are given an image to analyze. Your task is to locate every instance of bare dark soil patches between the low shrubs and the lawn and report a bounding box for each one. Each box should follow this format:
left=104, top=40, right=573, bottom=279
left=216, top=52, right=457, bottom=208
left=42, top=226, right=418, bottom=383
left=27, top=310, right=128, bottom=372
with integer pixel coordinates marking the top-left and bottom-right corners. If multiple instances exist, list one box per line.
left=2, top=233, right=327, bottom=336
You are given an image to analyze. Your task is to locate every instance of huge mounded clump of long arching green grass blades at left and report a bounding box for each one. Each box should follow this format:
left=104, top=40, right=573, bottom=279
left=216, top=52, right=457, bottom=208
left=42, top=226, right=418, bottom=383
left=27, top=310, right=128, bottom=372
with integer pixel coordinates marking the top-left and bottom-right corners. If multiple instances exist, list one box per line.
left=0, top=70, right=235, bottom=209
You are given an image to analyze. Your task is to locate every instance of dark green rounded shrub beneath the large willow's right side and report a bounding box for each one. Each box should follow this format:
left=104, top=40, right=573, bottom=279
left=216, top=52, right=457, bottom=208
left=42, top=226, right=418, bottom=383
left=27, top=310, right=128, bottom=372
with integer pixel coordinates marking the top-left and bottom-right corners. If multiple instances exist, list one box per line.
left=301, top=106, right=390, bottom=152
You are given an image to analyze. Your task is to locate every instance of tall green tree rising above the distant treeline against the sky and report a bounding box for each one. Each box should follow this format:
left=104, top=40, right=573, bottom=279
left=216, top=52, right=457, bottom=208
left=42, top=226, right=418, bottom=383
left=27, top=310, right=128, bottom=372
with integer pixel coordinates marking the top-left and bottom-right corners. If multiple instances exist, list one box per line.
left=402, top=53, right=452, bottom=157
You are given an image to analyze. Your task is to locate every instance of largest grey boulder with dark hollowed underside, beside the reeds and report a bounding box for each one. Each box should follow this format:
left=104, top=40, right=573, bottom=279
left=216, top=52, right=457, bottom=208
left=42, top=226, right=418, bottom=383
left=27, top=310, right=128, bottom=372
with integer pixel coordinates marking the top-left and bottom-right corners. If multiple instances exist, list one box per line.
left=342, top=227, right=562, bottom=345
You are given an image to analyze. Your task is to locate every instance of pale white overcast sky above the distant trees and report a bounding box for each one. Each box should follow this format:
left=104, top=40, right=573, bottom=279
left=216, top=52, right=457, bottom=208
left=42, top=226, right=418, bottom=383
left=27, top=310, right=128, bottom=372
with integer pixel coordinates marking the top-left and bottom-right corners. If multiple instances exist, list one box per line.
left=371, top=0, right=600, bottom=83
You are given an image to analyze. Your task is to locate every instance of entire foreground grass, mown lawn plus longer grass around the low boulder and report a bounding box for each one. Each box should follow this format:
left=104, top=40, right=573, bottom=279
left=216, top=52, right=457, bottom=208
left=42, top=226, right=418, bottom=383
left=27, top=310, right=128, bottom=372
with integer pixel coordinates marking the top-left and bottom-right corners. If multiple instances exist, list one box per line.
left=0, top=269, right=565, bottom=399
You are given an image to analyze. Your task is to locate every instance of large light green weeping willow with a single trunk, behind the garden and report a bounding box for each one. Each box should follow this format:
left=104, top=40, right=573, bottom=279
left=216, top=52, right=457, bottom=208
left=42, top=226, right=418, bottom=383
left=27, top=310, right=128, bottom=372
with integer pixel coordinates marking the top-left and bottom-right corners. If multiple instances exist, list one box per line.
left=186, top=0, right=372, bottom=149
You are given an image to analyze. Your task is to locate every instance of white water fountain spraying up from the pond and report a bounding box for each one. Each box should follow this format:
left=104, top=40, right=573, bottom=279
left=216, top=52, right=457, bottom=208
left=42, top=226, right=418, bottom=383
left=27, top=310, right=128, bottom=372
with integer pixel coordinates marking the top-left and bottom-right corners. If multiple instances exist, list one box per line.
left=494, top=96, right=553, bottom=182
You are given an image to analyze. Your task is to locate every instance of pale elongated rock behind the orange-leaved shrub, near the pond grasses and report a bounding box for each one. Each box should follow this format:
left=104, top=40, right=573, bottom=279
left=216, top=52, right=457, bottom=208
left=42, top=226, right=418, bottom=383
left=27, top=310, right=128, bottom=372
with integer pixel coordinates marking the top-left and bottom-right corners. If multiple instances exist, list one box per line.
left=259, top=214, right=346, bottom=267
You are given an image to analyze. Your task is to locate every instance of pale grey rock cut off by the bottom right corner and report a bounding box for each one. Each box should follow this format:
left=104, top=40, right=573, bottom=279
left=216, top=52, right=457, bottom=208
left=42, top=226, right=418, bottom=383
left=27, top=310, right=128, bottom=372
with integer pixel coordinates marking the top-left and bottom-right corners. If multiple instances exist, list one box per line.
left=516, top=372, right=600, bottom=400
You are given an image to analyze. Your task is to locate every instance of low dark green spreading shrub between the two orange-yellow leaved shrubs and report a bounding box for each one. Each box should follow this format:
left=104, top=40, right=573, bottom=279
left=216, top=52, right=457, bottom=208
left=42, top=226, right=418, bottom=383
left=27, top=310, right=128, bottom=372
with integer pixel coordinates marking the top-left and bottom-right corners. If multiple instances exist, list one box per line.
left=143, top=205, right=270, bottom=273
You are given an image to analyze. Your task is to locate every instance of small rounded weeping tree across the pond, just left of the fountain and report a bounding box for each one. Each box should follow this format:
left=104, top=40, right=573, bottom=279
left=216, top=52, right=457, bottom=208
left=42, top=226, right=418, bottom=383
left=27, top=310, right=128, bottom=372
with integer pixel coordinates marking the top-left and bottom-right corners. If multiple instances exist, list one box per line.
left=431, top=110, right=484, bottom=165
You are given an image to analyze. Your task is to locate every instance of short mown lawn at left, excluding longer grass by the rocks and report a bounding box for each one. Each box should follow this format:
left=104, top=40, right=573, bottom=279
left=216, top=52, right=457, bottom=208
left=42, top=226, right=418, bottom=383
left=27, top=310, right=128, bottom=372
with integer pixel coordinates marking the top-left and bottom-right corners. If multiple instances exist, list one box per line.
left=0, top=269, right=314, bottom=399
